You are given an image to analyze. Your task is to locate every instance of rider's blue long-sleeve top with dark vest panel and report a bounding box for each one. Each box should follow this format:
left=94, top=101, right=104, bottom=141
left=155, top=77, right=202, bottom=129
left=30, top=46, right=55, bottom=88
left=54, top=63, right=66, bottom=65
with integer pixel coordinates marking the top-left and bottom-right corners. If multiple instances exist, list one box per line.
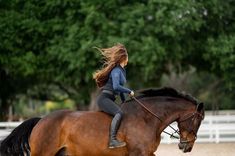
left=103, top=66, right=131, bottom=102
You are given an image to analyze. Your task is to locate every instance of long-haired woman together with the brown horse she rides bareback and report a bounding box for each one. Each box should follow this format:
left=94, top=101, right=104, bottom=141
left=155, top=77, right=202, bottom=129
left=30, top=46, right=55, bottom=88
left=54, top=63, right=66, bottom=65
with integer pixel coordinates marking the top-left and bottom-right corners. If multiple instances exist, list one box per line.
left=0, top=44, right=204, bottom=156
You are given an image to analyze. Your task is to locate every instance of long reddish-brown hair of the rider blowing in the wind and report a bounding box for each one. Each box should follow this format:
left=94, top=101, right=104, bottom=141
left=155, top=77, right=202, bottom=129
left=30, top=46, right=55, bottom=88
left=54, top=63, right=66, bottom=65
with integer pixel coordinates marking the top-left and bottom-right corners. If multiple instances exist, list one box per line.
left=93, top=43, right=128, bottom=88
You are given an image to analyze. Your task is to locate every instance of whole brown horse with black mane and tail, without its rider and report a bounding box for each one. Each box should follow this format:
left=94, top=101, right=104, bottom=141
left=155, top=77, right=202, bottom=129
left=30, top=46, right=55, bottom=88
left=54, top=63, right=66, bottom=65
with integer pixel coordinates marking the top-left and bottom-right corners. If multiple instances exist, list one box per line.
left=0, top=88, right=204, bottom=156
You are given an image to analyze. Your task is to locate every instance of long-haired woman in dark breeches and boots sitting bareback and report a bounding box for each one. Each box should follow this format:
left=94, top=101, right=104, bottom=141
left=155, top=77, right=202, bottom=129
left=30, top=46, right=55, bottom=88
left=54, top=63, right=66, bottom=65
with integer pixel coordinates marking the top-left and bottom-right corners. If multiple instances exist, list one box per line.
left=93, top=44, right=134, bottom=148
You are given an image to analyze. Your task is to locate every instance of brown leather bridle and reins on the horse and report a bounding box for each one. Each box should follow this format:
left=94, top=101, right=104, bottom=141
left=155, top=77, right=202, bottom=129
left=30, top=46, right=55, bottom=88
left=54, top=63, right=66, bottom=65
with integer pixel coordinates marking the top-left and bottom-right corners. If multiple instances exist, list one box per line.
left=132, top=96, right=203, bottom=143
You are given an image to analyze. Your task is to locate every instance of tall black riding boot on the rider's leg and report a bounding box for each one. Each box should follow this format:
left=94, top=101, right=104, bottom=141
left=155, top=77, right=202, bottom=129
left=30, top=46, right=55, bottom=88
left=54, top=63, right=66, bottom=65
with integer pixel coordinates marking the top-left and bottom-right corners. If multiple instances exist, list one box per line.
left=109, top=113, right=126, bottom=148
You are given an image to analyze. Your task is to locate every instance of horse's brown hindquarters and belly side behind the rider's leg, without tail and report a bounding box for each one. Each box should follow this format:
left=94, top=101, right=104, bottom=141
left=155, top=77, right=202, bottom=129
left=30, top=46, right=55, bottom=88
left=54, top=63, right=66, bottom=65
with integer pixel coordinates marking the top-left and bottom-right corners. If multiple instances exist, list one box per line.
left=30, top=111, right=129, bottom=156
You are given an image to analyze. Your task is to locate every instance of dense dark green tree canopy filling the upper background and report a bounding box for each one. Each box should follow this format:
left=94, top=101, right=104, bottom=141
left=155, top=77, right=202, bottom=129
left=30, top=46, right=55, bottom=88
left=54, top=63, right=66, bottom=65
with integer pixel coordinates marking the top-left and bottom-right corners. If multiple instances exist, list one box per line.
left=0, top=0, right=235, bottom=119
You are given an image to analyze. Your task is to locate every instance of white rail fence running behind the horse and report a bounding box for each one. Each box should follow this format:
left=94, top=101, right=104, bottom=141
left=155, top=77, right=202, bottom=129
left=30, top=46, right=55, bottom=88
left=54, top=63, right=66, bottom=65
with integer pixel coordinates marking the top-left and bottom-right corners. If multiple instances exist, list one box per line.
left=0, top=115, right=235, bottom=144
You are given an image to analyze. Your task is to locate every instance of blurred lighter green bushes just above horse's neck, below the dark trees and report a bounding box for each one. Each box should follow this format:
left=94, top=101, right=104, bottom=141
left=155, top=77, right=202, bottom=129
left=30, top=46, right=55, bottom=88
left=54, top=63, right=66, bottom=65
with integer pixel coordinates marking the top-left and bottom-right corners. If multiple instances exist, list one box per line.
left=161, top=67, right=235, bottom=110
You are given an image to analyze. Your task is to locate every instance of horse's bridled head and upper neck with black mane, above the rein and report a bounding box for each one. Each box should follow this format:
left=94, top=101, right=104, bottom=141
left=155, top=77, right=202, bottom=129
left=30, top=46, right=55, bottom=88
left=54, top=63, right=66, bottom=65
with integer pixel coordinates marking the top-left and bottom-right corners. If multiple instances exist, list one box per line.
left=131, top=87, right=204, bottom=152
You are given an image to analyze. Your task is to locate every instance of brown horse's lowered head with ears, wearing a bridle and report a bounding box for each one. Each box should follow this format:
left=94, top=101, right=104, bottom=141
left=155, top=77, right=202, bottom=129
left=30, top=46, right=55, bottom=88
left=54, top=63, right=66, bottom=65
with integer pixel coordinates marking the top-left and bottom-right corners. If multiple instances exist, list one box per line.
left=177, top=103, right=204, bottom=153
